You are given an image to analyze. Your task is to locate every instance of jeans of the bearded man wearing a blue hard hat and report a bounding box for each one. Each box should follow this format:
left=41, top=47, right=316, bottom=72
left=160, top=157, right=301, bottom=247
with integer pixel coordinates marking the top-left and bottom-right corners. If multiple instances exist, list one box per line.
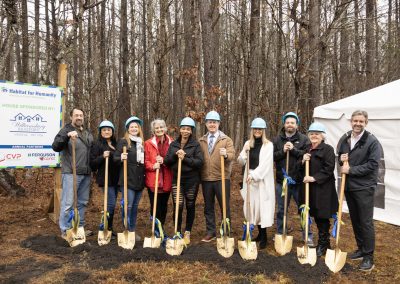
left=275, top=183, right=313, bottom=240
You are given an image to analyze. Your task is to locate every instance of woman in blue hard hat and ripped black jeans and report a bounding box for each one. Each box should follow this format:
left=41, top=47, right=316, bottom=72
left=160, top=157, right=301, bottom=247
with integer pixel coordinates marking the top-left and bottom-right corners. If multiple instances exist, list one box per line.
left=164, top=117, right=204, bottom=245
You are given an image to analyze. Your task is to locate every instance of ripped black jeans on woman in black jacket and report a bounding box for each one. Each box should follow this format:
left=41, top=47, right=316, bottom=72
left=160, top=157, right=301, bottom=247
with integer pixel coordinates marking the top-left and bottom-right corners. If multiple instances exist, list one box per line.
left=172, top=180, right=199, bottom=232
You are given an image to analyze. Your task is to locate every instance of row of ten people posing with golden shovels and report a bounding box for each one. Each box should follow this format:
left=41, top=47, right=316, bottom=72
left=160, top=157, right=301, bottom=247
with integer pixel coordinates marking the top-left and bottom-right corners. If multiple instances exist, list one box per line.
left=52, top=108, right=381, bottom=270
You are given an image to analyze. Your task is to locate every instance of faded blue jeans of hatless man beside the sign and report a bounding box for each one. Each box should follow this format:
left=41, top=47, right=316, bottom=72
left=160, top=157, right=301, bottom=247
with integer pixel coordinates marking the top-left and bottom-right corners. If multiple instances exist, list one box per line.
left=59, top=174, right=90, bottom=233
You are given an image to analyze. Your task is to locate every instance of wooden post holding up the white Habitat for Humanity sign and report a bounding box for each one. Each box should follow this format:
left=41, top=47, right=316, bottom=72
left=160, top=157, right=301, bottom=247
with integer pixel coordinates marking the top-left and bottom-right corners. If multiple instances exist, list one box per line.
left=47, top=64, right=68, bottom=224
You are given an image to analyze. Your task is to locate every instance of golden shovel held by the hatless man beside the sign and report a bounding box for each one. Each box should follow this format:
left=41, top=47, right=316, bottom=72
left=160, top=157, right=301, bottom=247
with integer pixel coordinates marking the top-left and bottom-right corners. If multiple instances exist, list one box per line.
left=66, top=138, right=86, bottom=247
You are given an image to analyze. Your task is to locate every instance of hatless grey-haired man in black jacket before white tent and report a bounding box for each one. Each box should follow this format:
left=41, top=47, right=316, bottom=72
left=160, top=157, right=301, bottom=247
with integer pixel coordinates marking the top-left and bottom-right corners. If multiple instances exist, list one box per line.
left=338, top=110, right=381, bottom=271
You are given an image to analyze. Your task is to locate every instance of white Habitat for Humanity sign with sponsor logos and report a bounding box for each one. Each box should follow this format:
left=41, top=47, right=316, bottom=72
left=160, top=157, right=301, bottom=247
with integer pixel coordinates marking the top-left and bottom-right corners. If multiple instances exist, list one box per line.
left=0, top=81, right=63, bottom=168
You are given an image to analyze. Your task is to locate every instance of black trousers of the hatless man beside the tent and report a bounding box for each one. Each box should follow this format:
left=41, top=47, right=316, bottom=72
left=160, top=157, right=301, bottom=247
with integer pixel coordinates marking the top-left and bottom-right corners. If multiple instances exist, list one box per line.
left=345, top=187, right=375, bottom=257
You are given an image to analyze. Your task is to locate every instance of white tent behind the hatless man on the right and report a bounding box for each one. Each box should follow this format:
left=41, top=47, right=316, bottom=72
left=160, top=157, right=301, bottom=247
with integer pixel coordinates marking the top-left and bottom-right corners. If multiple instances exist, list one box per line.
left=314, top=80, right=400, bottom=225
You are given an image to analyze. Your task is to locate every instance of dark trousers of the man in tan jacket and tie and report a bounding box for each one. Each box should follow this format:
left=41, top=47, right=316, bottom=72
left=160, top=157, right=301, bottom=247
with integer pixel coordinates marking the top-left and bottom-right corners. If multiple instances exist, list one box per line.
left=201, top=179, right=232, bottom=237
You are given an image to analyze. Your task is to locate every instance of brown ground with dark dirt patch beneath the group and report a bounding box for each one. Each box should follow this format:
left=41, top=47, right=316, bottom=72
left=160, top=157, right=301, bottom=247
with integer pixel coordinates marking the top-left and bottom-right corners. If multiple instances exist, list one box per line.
left=0, top=168, right=400, bottom=283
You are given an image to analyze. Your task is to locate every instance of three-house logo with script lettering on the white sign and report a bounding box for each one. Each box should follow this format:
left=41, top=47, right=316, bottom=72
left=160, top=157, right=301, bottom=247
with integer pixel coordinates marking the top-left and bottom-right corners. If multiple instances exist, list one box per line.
left=10, top=113, right=47, bottom=133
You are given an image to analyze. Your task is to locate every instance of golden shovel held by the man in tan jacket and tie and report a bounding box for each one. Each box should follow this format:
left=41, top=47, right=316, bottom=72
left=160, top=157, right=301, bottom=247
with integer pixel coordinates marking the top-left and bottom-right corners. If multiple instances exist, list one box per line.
left=217, top=156, right=235, bottom=258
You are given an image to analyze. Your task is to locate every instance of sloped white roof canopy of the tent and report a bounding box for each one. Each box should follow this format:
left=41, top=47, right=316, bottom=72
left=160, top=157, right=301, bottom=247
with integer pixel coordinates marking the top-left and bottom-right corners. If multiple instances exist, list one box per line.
left=314, top=80, right=400, bottom=119
